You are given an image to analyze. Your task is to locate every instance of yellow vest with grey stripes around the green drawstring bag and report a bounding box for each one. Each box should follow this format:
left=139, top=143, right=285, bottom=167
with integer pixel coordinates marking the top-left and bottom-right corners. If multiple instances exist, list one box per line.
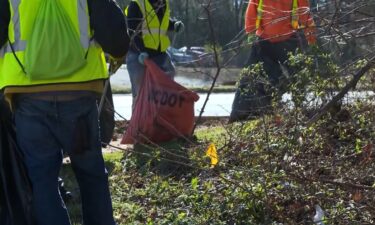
left=0, top=0, right=108, bottom=89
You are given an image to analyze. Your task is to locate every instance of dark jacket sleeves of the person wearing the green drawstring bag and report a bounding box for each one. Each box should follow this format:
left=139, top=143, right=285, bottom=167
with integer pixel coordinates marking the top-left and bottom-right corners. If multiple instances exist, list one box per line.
left=0, top=0, right=130, bottom=57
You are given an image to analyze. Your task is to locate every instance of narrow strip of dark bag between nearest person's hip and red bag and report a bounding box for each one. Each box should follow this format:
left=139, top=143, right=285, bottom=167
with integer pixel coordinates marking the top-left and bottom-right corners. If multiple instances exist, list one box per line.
left=99, top=80, right=115, bottom=147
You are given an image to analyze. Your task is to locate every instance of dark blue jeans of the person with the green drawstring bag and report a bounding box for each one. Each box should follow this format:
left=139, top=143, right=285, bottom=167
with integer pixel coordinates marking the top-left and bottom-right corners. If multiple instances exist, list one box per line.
left=15, top=96, right=115, bottom=225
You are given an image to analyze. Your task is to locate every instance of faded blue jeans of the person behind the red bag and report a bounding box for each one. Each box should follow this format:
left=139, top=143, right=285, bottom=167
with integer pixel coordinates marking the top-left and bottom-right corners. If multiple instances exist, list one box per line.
left=126, top=51, right=176, bottom=102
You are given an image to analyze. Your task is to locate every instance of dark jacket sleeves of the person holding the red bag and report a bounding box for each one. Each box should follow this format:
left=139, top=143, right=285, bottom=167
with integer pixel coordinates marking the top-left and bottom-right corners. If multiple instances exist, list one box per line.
left=126, top=0, right=176, bottom=56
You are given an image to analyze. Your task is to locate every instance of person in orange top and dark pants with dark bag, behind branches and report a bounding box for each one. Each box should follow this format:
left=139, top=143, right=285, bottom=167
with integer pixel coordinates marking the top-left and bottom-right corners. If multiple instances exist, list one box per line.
left=229, top=0, right=316, bottom=122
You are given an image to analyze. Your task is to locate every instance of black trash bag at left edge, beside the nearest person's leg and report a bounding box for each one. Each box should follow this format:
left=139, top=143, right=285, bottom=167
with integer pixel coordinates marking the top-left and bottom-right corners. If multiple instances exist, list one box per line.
left=0, top=94, right=36, bottom=225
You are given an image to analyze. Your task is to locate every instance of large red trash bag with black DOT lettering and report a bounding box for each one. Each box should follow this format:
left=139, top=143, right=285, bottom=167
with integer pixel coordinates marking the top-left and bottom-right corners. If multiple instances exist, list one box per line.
left=121, top=59, right=199, bottom=144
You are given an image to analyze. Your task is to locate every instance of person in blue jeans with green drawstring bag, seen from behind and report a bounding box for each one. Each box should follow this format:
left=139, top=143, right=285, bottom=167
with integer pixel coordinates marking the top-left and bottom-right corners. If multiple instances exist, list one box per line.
left=0, top=0, right=130, bottom=225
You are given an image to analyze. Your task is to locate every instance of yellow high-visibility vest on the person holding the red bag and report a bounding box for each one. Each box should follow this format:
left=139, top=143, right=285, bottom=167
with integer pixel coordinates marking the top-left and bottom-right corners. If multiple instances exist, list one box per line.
left=134, top=0, right=170, bottom=52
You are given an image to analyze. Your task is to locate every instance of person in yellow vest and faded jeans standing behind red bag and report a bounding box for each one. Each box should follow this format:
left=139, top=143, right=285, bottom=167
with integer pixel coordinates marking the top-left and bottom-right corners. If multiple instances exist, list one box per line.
left=125, top=0, right=184, bottom=104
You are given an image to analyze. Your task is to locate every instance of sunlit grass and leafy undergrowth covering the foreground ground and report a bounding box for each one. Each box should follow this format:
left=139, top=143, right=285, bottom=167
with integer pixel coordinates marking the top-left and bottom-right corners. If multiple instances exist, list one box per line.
left=63, top=101, right=375, bottom=225
